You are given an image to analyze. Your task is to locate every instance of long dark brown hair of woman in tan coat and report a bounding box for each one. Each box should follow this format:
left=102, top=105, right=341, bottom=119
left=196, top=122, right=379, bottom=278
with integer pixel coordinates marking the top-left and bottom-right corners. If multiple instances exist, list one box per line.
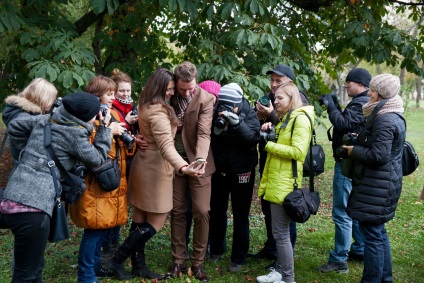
left=138, top=68, right=178, bottom=123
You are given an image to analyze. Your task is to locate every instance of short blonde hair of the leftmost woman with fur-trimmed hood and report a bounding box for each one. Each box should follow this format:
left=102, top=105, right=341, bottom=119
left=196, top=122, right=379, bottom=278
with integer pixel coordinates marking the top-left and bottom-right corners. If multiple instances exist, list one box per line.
left=18, top=78, right=57, bottom=114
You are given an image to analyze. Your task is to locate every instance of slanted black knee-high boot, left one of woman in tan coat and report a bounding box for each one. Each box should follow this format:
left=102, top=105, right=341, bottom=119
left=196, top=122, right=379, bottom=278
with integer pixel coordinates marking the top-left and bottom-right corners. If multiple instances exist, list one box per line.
left=105, top=223, right=156, bottom=280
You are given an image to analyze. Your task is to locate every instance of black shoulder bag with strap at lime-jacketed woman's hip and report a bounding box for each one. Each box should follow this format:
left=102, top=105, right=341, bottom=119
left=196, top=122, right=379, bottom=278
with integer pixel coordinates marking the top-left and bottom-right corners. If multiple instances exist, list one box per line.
left=283, top=113, right=320, bottom=223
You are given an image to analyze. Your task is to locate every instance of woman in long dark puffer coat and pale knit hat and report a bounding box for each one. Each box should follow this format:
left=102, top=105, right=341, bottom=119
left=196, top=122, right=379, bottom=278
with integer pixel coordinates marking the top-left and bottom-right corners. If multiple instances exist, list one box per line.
left=343, top=74, right=406, bottom=283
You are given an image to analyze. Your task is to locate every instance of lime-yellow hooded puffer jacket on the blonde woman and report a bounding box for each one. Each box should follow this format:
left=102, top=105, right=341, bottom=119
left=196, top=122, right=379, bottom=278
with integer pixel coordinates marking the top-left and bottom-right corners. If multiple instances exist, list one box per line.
left=258, top=106, right=314, bottom=204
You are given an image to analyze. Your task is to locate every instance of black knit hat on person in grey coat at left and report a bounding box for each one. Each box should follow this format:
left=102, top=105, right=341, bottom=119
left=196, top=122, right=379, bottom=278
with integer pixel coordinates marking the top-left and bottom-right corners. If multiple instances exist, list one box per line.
left=62, top=92, right=100, bottom=122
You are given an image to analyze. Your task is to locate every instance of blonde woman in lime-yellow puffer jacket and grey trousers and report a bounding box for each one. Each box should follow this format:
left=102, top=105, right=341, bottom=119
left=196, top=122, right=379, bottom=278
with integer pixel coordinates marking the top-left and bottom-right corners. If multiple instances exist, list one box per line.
left=257, top=82, right=314, bottom=283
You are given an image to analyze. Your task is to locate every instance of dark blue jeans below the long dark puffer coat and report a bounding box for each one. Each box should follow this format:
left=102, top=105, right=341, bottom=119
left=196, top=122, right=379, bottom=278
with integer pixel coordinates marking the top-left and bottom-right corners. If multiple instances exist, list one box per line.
left=359, top=223, right=393, bottom=283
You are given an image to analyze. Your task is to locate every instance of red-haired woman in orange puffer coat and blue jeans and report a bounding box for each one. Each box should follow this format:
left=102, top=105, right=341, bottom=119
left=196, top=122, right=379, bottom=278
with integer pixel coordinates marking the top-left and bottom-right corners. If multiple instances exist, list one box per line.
left=70, top=76, right=135, bottom=283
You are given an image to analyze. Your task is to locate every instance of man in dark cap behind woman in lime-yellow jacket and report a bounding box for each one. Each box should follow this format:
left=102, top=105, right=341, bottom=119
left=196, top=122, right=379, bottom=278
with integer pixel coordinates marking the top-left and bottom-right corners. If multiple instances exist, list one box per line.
left=249, top=64, right=308, bottom=267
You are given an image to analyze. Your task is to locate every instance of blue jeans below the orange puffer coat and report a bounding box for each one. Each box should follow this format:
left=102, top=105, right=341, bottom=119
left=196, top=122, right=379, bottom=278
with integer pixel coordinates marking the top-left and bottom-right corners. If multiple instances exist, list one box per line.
left=78, top=229, right=108, bottom=283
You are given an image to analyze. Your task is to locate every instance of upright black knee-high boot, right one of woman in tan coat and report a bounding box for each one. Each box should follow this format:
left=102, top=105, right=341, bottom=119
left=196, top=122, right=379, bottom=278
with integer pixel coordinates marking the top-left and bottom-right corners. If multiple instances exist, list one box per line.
left=131, top=223, right=164, bottom=280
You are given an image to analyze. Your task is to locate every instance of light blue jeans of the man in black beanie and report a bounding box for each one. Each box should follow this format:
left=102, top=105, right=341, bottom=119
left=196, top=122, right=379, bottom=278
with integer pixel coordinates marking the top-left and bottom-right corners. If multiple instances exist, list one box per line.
left=328, top=161, right=364, bottom=262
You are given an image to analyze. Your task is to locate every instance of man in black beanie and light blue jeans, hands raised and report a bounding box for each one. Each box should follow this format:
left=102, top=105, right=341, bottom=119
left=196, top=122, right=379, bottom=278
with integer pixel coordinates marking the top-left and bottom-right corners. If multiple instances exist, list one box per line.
left=317, top=68, right=371, bottom=273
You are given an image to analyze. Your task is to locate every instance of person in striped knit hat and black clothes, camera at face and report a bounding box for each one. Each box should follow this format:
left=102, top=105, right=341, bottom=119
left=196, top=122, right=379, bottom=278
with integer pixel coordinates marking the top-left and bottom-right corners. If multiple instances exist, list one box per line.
left=209, top=83, right=260, bottom=272
